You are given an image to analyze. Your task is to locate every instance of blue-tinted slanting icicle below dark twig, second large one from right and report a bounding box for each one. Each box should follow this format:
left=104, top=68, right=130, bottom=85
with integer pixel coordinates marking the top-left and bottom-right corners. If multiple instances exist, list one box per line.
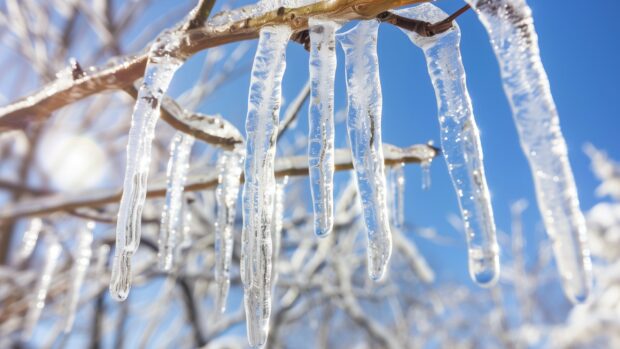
left=396, top=4, right=499, bottom=286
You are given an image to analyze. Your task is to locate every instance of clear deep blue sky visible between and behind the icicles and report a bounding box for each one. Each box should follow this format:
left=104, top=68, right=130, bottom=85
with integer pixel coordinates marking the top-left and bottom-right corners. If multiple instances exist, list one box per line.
left=166, top=0, right=620, bottom=282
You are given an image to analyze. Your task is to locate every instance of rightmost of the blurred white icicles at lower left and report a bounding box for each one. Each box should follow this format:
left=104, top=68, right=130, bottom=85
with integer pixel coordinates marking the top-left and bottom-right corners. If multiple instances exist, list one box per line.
left=65, top=221, right=95, bottom=333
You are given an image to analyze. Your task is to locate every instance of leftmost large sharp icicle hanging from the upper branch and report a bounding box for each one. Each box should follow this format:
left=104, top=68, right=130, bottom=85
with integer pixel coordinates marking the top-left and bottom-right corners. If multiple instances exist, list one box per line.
left=110, top=32, right=182, bottom=301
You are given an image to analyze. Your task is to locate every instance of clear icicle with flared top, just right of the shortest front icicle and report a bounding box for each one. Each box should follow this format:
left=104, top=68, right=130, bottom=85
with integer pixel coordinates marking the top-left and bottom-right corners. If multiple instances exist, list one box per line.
left=338, top=20, right=392, bottom=280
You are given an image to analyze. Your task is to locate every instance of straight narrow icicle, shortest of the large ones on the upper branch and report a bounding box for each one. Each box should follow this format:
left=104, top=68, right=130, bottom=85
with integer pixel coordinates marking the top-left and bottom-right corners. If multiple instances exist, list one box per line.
left=308, top=18, right=340, bottom=237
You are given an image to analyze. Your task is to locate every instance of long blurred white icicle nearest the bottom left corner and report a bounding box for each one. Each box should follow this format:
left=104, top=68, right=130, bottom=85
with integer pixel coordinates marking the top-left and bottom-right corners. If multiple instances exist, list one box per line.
left=22, top=237, right=62, bottom=341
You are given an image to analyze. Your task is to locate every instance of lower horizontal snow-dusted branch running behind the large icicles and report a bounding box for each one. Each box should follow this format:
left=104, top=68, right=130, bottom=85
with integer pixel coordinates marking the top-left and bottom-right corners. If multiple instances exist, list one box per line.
left=0, top=144, right=439, bottom=221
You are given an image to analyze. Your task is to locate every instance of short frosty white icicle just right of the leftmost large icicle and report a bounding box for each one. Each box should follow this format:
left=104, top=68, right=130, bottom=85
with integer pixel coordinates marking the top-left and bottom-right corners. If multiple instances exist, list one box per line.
left=157, top=131, right=194, bottom=271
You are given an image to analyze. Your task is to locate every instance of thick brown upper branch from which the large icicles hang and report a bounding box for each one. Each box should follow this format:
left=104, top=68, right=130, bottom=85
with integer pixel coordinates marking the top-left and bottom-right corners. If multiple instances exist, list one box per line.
left=0, top=0, right=428, bottom=138
